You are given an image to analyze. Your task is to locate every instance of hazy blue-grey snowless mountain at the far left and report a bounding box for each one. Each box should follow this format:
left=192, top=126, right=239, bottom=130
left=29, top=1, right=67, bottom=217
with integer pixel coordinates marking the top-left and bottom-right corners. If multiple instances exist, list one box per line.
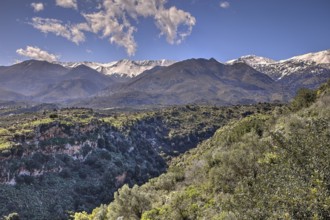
left=0, top=60, right=112, bottom=102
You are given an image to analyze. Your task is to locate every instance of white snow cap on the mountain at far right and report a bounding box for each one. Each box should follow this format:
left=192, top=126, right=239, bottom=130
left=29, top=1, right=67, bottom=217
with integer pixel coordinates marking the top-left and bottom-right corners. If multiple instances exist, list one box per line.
left=226, top=50, right=330, bottom=81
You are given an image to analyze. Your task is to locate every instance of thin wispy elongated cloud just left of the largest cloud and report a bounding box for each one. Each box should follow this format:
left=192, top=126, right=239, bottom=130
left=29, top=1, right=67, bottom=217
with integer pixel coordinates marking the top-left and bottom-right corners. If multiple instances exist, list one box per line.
left=30, top=17, right=90, bottom=45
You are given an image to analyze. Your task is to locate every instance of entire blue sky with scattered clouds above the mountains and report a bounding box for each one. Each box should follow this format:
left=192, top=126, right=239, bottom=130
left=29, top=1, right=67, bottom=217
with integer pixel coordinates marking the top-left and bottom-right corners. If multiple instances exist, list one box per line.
left=0, top=0, right=330, bottom=65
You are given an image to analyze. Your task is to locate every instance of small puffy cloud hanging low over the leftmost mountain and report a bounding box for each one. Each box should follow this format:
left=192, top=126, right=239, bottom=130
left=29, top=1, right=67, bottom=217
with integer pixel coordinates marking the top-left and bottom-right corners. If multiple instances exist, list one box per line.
left=16, top=46, right=59, bottom=62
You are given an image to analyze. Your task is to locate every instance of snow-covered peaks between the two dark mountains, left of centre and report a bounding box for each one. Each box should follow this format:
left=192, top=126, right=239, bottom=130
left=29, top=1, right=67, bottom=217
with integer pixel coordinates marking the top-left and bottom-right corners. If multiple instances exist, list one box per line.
left=59, top=59, right=175, bottom=78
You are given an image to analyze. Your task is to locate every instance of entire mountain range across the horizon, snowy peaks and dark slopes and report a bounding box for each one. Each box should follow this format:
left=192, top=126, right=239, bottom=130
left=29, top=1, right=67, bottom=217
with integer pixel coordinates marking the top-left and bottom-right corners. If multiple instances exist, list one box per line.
left=0, top=50, right=330, bottom=108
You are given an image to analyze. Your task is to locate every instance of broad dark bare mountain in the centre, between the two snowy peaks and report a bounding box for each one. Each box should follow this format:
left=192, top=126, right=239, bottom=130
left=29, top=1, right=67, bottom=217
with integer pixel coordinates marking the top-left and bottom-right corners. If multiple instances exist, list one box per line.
left=78, top=58, right=282, bottom=107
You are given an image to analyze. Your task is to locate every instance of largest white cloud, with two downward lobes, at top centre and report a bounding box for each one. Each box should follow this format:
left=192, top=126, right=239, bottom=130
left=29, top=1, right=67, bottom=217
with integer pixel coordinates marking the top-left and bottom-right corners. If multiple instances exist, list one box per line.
left=83, top=0, right=196, bottom=56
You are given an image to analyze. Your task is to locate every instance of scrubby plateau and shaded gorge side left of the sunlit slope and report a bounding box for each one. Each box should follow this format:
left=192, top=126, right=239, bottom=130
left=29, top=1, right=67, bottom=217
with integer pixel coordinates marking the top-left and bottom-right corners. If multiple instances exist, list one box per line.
left=0, top=104, right=275, bottom=219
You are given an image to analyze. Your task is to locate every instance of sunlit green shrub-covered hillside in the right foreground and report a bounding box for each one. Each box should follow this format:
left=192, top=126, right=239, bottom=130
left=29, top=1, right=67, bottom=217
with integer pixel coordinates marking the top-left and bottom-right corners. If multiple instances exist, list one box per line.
left=73, top=81, right=330, bottom=220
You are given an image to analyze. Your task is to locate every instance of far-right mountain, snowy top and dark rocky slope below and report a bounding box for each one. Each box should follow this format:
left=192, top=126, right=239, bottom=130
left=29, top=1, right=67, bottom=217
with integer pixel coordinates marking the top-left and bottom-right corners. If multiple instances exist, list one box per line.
left=227, top=50, right=330, bottom=98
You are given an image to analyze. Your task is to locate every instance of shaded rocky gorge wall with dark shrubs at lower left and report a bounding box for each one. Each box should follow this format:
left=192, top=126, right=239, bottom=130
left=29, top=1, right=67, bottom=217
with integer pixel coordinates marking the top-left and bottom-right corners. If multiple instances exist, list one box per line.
left=0, top=116, right=166, bottom=219
